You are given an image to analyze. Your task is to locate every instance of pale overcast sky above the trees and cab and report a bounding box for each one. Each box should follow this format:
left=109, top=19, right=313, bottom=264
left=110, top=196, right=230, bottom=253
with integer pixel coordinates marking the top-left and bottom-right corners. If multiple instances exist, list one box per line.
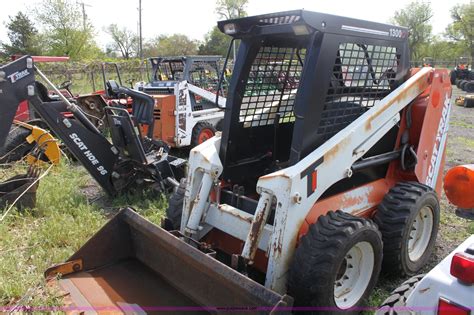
left=0, top=0, right=471, bottom=47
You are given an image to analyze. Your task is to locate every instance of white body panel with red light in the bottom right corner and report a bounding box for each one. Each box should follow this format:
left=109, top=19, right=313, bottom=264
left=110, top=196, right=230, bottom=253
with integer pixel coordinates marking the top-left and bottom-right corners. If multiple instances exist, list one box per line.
left=406, top=235, right=474, bottom=315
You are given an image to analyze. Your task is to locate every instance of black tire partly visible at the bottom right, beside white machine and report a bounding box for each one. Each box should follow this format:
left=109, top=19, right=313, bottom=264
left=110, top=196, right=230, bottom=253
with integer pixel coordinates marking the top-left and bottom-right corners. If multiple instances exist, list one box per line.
left=375, top=274, right=425, bottom=315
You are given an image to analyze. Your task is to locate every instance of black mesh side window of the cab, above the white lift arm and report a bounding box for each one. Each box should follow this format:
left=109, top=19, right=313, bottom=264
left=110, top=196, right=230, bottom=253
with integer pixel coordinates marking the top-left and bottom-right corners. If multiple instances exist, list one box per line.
left=318, top=43, right=400, bottom=140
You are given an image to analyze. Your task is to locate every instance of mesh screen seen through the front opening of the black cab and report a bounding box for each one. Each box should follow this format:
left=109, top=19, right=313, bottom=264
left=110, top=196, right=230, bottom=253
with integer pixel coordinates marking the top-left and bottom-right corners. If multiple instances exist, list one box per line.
left=239, top=46, right=306, bottom=128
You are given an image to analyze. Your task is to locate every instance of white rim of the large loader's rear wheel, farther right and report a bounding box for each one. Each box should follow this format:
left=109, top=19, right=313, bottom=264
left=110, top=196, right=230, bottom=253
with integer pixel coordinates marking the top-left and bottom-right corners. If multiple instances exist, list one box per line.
left=408, top=206, right=433, bottom=261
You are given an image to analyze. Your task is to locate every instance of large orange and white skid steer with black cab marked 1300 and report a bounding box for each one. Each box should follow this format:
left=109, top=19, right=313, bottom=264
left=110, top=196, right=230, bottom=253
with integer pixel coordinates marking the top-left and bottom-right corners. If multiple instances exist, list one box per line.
left=42, top=10, right=451, bottom=314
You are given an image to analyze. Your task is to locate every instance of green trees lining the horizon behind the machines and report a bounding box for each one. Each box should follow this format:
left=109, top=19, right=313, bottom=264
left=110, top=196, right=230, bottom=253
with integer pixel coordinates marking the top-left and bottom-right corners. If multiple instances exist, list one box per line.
left=0, top=0, right=474, bottom=60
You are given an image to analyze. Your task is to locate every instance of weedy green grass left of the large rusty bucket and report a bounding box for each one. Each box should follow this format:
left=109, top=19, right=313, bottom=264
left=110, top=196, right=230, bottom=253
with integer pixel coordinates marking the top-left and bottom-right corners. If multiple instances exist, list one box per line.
left=0, top=161, right=166, bottom=306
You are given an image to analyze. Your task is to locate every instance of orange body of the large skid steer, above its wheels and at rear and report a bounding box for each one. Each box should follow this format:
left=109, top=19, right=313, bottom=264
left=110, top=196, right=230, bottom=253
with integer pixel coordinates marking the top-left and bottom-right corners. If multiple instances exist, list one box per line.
left=298, top=69, right=451, bottom=239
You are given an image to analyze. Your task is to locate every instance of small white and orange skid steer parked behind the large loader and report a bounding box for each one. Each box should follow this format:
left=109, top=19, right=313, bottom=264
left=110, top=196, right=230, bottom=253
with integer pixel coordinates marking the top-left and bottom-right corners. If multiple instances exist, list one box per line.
left=136, top=56, right=226, bottom=148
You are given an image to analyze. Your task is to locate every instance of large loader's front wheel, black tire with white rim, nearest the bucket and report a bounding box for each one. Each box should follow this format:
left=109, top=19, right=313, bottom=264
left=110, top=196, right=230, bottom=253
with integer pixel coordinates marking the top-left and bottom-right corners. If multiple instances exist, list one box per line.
left=288, top=210, right=382, bottom=314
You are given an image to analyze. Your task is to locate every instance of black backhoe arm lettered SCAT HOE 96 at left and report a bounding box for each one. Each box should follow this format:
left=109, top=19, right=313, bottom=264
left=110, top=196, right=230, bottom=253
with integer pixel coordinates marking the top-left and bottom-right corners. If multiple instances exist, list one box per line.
left=0, top=56, right=184, bottom=196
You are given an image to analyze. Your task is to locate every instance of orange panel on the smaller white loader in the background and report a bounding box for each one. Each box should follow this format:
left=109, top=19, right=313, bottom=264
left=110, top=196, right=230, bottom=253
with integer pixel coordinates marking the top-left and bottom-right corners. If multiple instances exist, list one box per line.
left=153, top=95, right=176, bottom=147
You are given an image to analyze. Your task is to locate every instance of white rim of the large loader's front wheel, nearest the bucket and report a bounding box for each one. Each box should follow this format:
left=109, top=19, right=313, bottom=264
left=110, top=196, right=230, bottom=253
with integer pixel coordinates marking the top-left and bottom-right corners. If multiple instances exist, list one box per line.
left=334, top=242, right=375, bottom=309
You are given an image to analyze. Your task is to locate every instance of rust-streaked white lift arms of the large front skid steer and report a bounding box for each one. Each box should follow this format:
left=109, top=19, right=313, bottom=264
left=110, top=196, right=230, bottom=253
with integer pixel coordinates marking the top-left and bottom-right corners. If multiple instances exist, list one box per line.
left=181, top=68, right=432, bottom=294
